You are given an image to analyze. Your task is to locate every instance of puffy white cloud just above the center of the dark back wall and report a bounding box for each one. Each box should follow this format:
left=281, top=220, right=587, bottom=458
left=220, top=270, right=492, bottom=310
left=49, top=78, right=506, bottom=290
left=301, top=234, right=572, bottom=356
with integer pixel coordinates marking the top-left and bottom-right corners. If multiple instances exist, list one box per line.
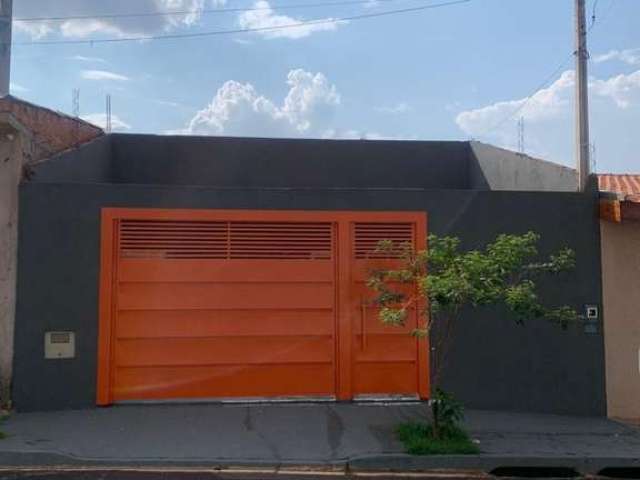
left=178, top=69, right=340, bottom=137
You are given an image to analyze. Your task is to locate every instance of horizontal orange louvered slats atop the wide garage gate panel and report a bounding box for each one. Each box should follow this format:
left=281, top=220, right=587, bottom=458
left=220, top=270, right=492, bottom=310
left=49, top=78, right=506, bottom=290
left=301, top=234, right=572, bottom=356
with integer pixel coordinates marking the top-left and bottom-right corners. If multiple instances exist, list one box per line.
left=120, top=220, right=333, bottom=260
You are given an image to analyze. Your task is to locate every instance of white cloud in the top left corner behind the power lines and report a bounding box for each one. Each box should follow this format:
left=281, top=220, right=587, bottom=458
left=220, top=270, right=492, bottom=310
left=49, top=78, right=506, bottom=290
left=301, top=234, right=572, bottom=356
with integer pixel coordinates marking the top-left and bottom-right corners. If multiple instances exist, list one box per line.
left=13, top=0, right=226, bottom=40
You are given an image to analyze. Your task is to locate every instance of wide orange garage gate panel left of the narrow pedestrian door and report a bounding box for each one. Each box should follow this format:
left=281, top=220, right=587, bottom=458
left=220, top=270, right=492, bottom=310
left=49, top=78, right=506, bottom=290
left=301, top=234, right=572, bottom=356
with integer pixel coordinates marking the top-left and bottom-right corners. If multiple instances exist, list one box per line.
left=99, top=212, right=335, bottom=401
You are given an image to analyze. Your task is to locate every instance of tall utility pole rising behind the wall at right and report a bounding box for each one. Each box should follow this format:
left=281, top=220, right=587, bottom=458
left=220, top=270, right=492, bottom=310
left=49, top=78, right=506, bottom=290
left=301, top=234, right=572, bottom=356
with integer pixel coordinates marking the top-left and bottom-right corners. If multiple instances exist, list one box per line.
left=575, top=0, right=589, bottom=192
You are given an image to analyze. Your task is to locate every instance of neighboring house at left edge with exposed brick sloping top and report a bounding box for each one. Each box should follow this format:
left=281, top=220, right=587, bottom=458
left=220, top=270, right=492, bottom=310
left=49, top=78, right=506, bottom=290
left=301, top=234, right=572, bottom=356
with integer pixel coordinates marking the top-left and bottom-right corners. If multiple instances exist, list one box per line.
left=0, top=96, right=102, bottom=406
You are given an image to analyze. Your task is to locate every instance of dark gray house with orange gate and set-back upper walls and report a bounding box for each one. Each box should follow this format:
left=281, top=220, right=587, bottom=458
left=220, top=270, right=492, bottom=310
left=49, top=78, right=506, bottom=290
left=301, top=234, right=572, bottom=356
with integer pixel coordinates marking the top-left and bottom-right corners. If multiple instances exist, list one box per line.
left=14, top=130, right=606, bottom=415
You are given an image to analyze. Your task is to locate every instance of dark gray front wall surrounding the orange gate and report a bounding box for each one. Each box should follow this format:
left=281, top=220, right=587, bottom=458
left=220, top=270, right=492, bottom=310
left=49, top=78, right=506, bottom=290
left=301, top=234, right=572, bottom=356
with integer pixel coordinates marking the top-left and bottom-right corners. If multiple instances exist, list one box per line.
left=14, top=183, right=605, bottom=415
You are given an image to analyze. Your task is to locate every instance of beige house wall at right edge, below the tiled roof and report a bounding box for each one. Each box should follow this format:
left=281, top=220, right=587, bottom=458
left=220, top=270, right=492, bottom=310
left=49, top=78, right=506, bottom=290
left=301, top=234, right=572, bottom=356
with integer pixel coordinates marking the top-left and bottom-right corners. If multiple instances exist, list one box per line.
left=601, top=221, right=640, bottom=420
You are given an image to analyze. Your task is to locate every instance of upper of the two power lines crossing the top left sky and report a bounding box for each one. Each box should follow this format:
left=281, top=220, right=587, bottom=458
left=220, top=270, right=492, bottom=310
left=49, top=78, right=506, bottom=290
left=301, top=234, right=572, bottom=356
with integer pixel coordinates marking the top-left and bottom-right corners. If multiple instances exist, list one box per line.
left=13, top=0, right=416, bottom=23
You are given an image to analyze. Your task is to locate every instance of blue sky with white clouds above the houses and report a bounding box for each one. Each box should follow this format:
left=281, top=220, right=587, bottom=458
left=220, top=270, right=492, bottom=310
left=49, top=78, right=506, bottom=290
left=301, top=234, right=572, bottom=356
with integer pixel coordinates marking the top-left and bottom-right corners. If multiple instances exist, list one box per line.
left=11, top=0, right=640, bottom=173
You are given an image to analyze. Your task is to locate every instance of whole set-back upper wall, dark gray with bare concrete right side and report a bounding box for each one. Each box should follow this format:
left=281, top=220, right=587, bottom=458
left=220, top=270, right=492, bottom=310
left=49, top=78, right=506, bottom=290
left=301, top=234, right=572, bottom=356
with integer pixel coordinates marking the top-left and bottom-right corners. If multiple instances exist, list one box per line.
left=28, top=134, right=577, bottom=192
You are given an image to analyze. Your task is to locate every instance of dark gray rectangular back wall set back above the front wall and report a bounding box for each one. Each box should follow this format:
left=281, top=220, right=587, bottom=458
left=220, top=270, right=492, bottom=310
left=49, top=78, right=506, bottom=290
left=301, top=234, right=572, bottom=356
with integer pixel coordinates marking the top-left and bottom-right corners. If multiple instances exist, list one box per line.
left=112, top=134, right=469, bottom=189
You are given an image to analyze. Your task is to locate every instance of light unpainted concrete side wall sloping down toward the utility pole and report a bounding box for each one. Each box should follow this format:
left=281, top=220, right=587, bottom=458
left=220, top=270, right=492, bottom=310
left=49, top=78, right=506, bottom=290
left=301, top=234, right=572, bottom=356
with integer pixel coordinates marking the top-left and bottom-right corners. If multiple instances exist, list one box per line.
left=469, top=142, right=578, bottom=192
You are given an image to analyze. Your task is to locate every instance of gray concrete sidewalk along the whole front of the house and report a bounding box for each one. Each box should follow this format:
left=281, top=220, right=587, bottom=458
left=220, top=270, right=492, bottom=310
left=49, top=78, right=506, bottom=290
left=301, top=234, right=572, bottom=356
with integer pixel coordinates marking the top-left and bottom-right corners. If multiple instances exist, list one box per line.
left=0, top=403, right=640, bottom=473
